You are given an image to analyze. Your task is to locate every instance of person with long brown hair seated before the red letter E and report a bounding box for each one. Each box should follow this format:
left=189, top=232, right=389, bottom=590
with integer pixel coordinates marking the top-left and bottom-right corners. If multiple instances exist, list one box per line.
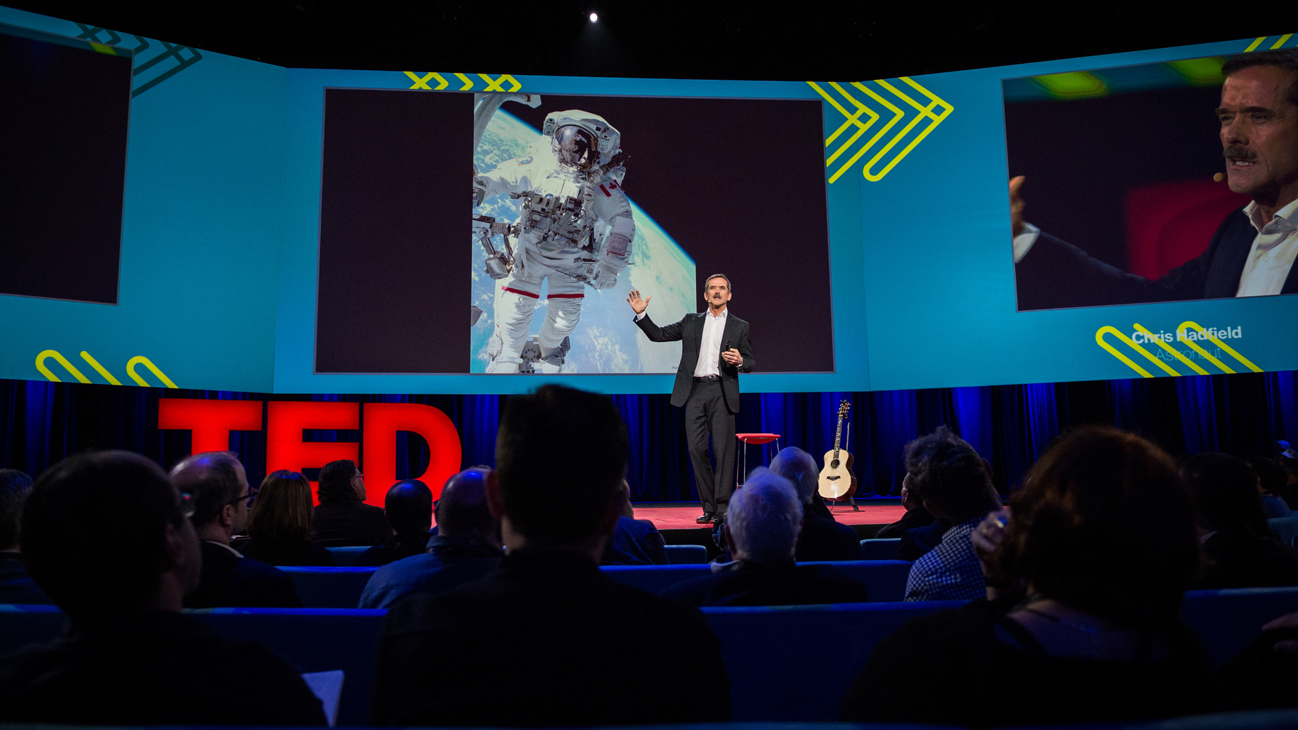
left=232, top=469, right=334, bottom=565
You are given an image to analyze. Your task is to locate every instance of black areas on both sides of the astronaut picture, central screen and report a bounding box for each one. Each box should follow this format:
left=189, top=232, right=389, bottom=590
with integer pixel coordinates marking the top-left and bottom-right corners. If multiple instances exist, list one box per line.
left=317, top=90, right=833, bottom=373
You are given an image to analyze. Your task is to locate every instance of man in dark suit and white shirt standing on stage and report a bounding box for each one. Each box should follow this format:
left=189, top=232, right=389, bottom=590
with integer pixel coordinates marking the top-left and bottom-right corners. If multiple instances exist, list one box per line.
left=627, top=274, right=757, bottom=523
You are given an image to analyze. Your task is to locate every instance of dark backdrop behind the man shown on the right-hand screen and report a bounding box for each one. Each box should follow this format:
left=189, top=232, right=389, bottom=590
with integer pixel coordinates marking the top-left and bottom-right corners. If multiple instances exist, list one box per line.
left=1005, top=86, right=1225, bottom=298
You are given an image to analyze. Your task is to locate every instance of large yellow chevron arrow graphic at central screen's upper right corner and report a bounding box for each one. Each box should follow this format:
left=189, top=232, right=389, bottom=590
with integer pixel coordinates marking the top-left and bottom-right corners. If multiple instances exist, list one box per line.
left=807, top=77, right=953, bottom=183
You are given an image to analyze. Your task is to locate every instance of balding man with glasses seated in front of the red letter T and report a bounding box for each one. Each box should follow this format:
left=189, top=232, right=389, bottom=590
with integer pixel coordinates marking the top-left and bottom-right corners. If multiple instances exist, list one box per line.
left=171, top=451, right=302, bottom=608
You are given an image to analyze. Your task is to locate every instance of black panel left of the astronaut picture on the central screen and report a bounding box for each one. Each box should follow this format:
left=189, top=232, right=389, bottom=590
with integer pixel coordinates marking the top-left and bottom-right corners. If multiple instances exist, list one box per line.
left=315, top=88, right=474, bottom=373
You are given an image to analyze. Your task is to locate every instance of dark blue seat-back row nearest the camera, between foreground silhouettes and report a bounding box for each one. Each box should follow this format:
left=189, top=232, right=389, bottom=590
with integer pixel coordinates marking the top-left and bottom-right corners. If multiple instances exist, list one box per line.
left=0, top=584, right=1298, bottom=729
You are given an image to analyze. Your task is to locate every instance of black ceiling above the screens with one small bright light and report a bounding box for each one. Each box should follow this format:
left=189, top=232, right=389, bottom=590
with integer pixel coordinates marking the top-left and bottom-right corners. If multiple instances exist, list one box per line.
left=0, top=0, right=1298, bottom=81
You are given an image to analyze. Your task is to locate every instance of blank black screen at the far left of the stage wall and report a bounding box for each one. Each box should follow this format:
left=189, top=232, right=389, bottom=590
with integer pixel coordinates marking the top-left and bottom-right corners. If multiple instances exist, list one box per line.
left=0, top=35, right=131, bottom=304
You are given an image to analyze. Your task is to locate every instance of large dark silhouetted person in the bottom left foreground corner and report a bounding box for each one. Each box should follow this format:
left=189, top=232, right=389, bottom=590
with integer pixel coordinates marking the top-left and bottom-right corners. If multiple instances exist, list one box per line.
left=0, top=451, right=325, bottom=726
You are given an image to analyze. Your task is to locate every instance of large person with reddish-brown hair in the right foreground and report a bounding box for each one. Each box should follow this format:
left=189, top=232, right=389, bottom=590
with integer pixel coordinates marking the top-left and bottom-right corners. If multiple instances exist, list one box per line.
left=842, top=427, right=1211, bottom=727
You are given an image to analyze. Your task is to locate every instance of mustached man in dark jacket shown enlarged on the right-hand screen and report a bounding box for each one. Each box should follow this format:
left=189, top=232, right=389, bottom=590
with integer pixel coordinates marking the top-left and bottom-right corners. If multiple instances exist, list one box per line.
left=1010, top=48, right=1298, bottom=309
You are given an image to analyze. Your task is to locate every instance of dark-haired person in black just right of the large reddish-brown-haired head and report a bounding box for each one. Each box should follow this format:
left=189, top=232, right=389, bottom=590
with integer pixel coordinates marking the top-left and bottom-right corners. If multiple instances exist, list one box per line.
left=1181, top=453, right=1298, bottom=588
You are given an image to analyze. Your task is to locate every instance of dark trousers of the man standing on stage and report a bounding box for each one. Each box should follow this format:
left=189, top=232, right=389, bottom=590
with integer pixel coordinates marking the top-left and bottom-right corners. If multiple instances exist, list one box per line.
left=685, top=381, right=735, bottom=514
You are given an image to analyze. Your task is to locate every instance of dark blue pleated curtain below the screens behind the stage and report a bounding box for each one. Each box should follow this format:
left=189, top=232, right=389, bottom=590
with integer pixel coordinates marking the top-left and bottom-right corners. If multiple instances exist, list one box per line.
left=0, top=371, right=1298, bottom=501
